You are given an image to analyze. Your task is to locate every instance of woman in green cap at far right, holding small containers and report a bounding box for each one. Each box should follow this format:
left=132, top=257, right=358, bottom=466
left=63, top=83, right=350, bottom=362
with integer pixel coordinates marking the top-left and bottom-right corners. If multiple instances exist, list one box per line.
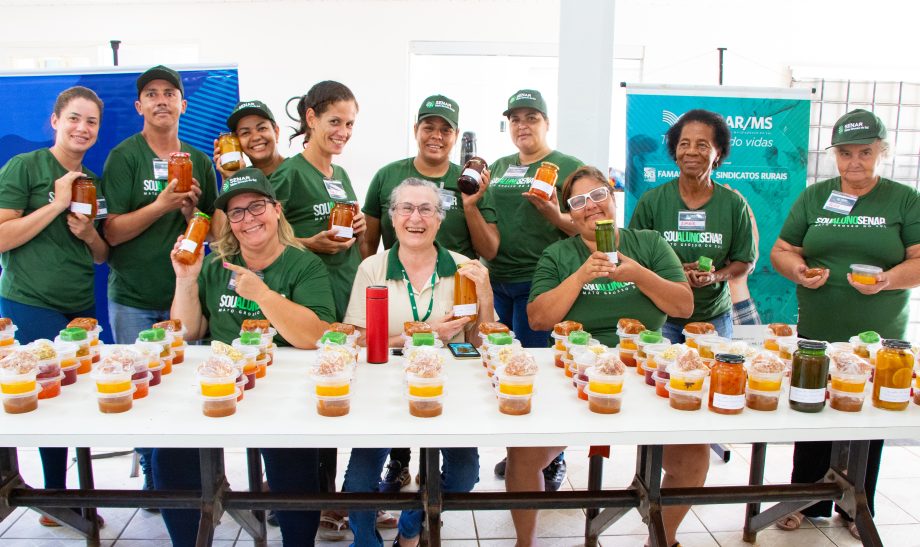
left=770, top=109, right=920, bottom=537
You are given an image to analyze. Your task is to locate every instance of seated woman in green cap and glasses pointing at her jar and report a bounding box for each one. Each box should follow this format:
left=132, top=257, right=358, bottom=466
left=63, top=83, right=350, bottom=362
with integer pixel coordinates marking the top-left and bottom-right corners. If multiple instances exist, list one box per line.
left=152, top=168, right=333, bottom=545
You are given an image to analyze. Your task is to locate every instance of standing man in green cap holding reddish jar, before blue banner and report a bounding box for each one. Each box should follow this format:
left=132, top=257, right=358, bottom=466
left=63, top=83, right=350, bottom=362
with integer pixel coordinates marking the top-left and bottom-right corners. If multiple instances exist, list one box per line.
left=102, top=65, right=217, bottom=344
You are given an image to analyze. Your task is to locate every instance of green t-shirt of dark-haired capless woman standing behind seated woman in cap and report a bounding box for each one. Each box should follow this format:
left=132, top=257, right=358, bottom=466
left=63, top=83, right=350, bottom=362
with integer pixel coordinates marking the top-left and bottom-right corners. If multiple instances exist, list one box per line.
left=269, top=154, right=361, bottom=321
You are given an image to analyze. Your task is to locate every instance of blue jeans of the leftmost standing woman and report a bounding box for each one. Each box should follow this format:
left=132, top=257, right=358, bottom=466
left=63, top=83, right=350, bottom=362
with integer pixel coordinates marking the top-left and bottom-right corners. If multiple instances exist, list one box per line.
left=0, top=297, right=96, bottom=489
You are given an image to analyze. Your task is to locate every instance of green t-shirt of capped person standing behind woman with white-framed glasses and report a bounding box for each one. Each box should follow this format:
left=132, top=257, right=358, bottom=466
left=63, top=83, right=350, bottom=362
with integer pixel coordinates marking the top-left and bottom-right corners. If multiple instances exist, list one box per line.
left=486, top=150, right=584, bottom=283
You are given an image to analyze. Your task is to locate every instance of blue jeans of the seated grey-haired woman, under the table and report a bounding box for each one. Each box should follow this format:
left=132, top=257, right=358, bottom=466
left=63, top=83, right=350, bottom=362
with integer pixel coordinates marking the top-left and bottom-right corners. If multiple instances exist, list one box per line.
left=342, top=448, right=479, bottom=547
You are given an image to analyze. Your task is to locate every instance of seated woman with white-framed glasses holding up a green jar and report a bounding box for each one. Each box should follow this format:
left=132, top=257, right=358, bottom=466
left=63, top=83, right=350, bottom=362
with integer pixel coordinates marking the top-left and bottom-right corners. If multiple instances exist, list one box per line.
left=505, top=167, right=696, bottom=545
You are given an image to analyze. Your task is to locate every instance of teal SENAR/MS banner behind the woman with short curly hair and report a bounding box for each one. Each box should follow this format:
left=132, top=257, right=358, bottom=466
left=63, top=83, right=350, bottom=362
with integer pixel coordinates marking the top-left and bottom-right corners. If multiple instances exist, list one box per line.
left=625, top=86, right=811, bottom=324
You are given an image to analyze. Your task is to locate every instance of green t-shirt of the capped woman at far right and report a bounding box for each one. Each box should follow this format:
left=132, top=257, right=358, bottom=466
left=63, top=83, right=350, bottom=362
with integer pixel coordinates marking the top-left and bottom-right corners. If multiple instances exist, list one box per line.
left=779, top=177, right=920, bottom=342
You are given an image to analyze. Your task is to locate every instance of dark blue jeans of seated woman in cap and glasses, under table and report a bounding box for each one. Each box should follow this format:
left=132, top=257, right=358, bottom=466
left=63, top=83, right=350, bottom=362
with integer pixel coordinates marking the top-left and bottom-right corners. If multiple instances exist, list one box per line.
left=152, top=448, right=319, bottom=547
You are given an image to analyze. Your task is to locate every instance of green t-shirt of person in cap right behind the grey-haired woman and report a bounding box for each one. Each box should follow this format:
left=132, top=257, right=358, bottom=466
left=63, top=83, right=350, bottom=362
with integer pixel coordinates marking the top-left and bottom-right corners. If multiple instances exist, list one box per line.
left=362, top=158, right=497, bottom=258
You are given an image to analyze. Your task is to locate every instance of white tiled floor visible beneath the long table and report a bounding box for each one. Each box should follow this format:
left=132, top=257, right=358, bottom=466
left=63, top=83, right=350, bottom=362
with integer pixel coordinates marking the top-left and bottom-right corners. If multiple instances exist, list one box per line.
left=0, top=443, right=920, bottom=547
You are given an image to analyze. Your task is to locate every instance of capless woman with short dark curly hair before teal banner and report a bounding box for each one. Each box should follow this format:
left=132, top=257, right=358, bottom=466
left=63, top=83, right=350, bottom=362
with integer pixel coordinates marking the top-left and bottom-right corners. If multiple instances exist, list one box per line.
left=629, top=109, right=754, bottom=343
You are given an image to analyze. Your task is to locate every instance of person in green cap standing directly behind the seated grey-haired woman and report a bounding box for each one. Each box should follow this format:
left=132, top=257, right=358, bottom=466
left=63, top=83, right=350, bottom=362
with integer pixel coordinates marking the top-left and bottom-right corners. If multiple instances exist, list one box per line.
left=362, top=95, right=498, bottom=260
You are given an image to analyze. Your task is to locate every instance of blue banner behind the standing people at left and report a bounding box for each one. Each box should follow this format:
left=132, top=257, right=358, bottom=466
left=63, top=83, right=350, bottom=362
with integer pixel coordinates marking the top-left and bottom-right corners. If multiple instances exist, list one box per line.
left=0, top=68, right=239, bottom=342
